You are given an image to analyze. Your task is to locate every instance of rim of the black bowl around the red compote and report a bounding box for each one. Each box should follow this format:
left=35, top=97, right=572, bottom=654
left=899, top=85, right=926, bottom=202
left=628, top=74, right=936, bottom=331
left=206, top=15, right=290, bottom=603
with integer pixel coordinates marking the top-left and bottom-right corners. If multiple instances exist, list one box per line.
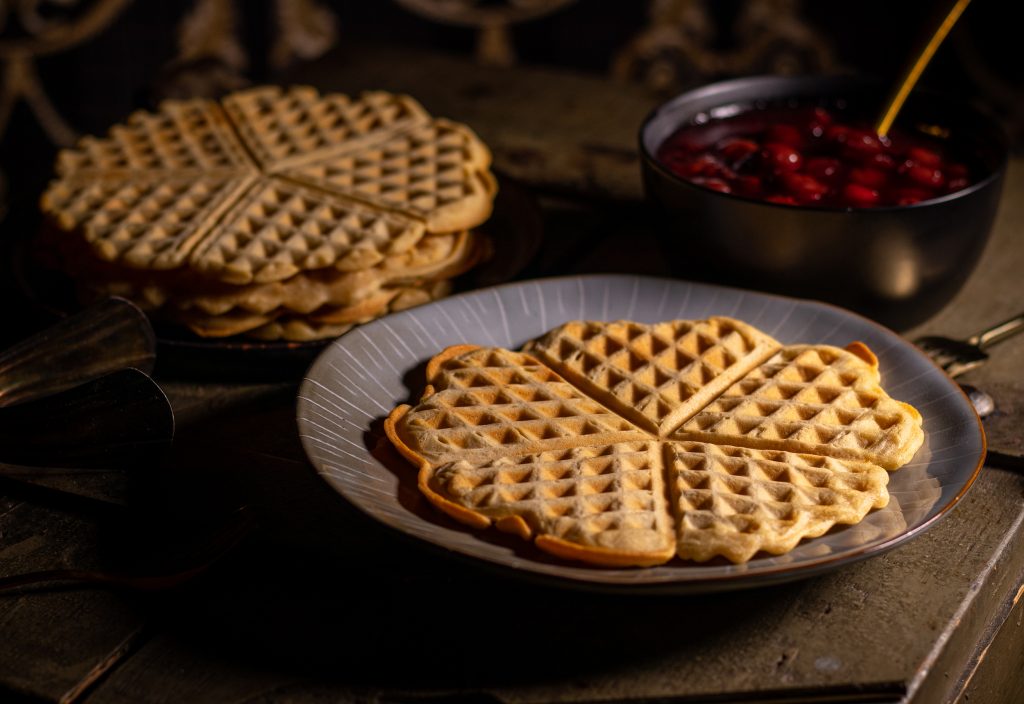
left=637, top=74, right=1010, bottom=214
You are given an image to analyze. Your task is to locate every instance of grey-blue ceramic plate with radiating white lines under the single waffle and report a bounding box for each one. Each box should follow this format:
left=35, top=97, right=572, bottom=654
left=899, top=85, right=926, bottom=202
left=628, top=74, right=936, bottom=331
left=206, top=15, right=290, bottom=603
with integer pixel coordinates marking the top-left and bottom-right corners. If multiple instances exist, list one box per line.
left=298, top=275, right=985, bottom=591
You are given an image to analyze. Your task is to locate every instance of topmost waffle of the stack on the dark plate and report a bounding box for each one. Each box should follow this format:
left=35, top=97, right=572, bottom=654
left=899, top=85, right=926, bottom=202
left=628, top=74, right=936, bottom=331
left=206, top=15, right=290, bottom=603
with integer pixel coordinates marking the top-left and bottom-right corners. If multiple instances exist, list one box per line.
left=36, top=87, right=495, bottom=284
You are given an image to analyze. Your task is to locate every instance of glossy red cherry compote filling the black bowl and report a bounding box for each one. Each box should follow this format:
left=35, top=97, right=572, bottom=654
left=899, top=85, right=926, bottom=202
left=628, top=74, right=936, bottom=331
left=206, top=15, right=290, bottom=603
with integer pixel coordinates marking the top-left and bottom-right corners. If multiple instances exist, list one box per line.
left=657, top=105, right=976, bottom=208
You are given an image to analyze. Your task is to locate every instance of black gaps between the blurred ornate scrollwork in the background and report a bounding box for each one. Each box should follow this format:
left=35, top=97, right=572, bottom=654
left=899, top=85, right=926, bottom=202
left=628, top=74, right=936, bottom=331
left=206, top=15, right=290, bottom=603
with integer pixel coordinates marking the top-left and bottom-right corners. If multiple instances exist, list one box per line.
left=0, top=0, right=1024, bottom=345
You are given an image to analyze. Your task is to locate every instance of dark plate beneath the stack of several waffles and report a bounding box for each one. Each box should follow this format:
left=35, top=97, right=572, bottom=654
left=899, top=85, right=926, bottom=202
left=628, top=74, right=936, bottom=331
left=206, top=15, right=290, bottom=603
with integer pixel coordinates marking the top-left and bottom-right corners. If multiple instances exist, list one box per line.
left=13, top=175, right=543, bottom=381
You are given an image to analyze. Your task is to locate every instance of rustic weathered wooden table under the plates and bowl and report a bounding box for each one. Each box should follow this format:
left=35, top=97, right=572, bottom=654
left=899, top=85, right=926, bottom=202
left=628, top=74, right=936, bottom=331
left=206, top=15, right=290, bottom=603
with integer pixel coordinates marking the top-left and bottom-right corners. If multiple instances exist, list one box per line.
left=0, top=46, right=1024, bottom=704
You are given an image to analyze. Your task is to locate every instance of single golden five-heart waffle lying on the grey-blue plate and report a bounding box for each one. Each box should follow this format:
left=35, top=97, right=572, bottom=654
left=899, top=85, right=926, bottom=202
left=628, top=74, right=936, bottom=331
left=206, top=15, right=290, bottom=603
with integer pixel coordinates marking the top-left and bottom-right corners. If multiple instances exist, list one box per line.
left=385, top=317, right=924, bottom=566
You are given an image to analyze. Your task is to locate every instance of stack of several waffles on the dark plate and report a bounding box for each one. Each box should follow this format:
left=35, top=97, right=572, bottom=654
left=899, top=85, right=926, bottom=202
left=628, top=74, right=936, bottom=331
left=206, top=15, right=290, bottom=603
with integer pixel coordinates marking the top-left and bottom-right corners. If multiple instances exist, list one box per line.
left=41, top=87, right=497, bottom=340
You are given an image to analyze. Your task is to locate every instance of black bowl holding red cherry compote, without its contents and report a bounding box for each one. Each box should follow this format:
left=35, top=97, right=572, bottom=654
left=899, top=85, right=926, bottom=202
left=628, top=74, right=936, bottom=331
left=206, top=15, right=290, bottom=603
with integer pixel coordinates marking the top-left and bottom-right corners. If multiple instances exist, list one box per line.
left=640, top=76, right=1008, bottom=328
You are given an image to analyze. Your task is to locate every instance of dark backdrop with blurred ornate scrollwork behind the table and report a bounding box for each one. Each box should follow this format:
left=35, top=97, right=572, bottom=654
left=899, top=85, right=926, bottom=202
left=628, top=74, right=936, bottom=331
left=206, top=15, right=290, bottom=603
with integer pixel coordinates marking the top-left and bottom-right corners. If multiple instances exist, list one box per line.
left=0, top=0, right=1024, bottom=224
